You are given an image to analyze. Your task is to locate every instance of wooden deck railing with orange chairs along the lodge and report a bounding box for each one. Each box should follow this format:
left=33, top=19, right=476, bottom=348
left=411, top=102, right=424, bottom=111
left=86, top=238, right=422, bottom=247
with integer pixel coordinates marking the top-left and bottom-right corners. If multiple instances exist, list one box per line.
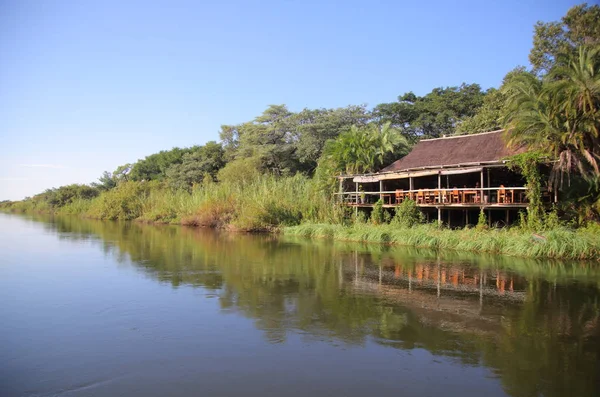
left=336, top=186, right=528, bottom=205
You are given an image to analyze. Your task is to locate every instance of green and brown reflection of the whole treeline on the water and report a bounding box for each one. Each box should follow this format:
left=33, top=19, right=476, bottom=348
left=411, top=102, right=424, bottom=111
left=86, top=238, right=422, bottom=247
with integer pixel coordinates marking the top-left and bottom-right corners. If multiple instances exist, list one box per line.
left=28, top=213, right=600, bottom=396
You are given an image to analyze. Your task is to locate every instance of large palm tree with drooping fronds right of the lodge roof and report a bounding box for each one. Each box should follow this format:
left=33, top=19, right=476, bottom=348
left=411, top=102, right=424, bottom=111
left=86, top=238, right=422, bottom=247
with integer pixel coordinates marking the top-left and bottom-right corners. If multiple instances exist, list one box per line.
left=503, top=47, right=600, bottom=186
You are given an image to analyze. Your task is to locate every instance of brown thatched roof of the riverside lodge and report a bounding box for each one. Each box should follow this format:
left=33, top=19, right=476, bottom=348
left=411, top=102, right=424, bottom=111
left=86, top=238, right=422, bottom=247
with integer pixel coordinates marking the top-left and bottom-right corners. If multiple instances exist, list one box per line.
left=380, top=130, right=525, bottom=172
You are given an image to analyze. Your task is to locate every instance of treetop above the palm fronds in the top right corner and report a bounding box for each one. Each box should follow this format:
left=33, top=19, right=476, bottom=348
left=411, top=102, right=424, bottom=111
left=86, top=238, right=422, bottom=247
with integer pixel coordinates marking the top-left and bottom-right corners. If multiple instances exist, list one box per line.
left=529, top=3, right=600, bottom=75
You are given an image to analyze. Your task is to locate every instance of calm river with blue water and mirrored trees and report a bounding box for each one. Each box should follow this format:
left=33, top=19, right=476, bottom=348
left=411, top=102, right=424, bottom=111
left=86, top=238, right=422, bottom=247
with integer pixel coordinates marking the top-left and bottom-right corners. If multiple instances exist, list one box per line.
left=0, top=214, right=600, bottom=397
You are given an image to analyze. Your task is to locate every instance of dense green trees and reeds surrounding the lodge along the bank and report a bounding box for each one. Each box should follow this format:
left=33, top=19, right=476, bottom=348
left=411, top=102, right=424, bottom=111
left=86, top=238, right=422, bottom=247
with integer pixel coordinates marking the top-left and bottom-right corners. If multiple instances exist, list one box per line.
left=0, top=4, right=600, bottom=235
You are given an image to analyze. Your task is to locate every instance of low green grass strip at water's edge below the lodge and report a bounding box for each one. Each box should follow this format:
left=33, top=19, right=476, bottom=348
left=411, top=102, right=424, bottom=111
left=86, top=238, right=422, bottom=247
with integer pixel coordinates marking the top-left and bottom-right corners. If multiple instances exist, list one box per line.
left=282, top=223, right=600, bottom=260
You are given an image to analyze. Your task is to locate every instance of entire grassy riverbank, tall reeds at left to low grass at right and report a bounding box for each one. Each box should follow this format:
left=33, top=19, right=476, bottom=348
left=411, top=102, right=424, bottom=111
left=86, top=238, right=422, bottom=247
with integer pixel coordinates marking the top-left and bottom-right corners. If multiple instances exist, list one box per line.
left=0, top=175, right=600, bottom=260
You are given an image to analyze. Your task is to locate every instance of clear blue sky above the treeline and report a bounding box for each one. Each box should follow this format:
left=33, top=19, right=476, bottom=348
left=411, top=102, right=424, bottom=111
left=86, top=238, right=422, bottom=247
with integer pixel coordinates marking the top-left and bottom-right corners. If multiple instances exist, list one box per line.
left=0, top=0, right=578, bottom=200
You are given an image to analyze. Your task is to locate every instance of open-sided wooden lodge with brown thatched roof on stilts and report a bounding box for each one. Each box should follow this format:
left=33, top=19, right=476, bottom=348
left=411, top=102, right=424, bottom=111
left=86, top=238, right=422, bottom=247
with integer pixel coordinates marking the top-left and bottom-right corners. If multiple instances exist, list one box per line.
left=337, top=130, right=558, bottom=226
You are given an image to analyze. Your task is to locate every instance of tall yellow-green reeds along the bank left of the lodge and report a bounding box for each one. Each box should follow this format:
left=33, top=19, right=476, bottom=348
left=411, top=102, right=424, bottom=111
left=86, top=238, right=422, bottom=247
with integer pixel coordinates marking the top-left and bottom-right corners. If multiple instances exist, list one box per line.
left=15, top=175, right=341, bottom=231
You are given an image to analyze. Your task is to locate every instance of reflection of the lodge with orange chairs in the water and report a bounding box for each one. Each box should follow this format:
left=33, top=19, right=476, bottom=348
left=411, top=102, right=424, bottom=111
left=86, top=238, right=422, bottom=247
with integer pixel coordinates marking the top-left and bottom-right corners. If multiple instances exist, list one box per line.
left=343, top=255, right=526, bottom=333
